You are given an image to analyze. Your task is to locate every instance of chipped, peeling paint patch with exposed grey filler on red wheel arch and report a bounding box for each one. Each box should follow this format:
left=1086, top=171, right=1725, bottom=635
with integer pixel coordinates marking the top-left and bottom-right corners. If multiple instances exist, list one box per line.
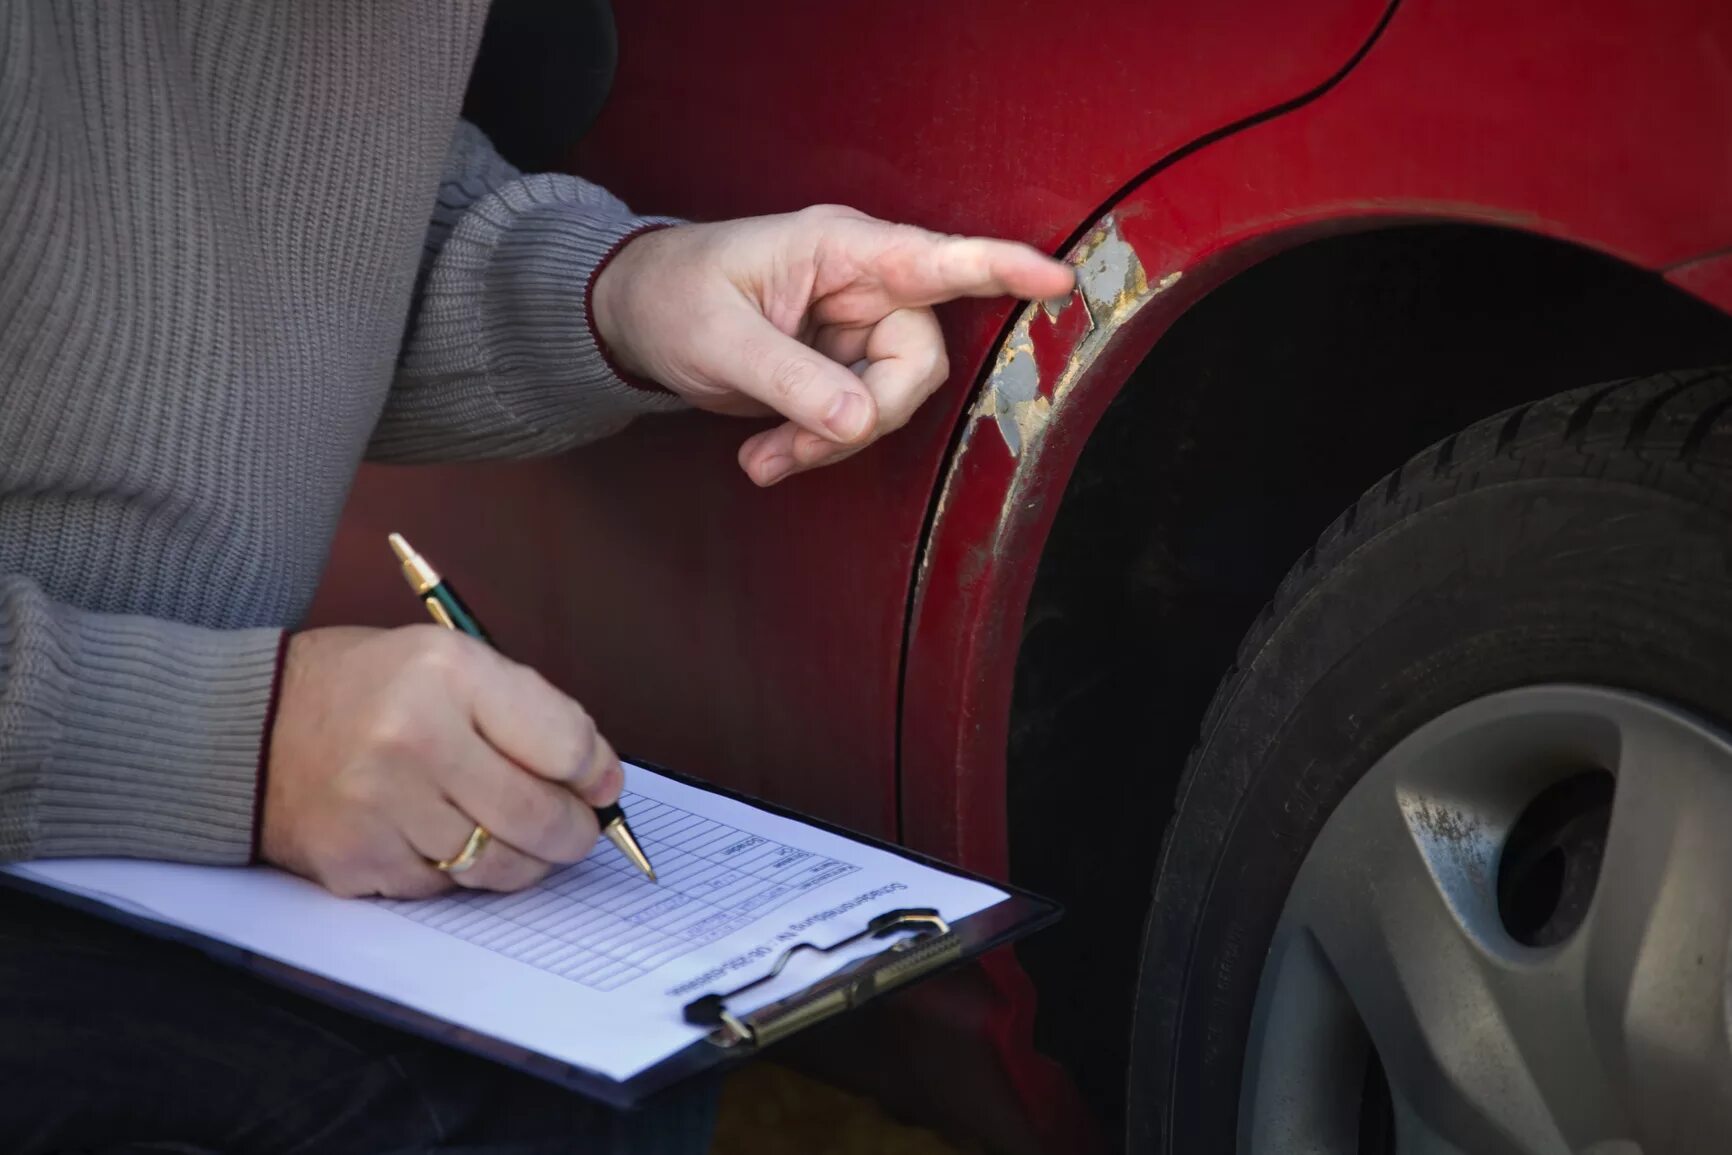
left=973, top=216, right=1179, bottom=457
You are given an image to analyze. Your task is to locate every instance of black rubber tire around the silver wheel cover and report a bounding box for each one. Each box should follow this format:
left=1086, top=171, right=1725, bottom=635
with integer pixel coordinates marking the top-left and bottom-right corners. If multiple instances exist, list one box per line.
left=1128, top=371, right=1732, bottom=1153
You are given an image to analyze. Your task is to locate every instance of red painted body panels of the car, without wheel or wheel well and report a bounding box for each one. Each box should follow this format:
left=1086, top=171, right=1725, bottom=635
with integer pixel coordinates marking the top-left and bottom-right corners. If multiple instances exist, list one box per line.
left=315, top=0, right=1732, bottom=1150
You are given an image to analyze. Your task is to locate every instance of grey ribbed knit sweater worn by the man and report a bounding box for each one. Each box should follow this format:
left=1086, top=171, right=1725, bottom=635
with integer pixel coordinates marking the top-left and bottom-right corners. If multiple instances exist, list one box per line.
left=0, top=0, right=677, bottom=862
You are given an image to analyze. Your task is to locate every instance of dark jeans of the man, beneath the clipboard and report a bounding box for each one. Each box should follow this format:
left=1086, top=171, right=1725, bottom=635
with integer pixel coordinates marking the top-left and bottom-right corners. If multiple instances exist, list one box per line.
left=0, top=887, right=715, bottom=1155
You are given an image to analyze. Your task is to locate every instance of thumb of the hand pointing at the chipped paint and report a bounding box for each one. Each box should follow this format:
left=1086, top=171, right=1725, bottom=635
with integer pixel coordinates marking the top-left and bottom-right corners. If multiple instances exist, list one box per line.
left=712, top=308, right=878, bottom=445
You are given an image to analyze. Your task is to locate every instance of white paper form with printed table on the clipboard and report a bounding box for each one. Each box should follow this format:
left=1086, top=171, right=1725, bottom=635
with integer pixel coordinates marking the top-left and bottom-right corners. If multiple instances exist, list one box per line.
left=3, top=764, right=1006, bottom=1081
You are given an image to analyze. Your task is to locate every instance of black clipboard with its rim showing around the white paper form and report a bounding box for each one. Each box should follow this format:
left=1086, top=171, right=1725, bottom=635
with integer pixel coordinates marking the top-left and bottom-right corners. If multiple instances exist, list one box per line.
left=0, top=757, right=1062, bottom=1110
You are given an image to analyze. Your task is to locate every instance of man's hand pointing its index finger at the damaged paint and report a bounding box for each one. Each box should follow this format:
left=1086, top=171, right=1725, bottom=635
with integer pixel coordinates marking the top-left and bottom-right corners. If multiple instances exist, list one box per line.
left=591, top=206, right=1074, bottom=485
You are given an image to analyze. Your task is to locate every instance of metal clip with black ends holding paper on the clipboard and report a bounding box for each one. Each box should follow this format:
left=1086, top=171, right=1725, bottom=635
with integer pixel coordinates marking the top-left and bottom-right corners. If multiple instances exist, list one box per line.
left=684, top=909, right=963, bottom=1048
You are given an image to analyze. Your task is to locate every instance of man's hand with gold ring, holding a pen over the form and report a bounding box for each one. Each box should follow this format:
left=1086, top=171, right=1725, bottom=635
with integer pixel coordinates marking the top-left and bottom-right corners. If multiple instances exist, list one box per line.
left=252, top=625, right=624, bottom=899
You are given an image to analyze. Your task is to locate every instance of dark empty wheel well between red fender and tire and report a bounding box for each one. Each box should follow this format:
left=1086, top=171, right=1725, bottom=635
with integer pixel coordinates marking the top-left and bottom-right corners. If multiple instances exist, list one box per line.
left=1008, top=225, right=1732, bottom=1120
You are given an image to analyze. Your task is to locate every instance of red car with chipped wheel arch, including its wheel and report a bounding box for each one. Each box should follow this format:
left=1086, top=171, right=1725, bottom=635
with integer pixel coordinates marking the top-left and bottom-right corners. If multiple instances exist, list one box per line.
left=315, top=0, right=1732, bottom=1155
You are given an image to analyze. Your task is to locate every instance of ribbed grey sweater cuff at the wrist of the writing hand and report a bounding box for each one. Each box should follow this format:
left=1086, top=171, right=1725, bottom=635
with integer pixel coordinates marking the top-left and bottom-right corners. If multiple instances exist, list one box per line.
left=10, top=613, right=282, bottom=864
